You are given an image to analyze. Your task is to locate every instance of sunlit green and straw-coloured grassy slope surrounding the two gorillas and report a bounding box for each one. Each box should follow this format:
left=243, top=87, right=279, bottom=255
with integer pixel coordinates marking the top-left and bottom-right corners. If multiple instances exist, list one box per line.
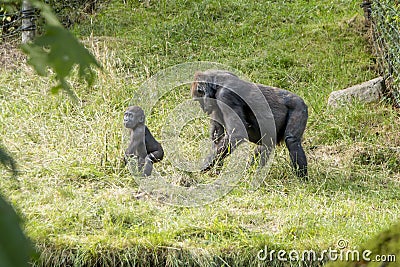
left=0, top=0, right=400, bottom=266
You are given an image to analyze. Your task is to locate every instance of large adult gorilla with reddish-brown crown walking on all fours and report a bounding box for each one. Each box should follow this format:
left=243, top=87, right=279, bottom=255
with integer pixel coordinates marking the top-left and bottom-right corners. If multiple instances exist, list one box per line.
left=191, top=70, right=308, bottom=177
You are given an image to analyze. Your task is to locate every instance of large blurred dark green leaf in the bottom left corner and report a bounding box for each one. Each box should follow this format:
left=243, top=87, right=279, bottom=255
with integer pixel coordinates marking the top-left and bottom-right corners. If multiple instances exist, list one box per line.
left=0, top=196, right=33, bottom=267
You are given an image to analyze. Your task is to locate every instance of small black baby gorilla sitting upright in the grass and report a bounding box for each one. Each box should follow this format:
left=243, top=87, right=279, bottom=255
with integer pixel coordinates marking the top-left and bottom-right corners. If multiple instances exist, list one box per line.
left=124, top=106, right=164, bottom=176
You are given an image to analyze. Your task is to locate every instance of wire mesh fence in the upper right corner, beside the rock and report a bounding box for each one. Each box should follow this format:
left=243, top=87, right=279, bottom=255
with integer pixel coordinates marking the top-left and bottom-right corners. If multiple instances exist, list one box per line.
left=362, top=0, right=400, bottom=108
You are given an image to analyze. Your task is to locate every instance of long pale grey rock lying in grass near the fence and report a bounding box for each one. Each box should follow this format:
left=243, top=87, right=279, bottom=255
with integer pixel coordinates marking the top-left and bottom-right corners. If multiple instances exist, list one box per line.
left=328, top=77, right=384, bottom=107
